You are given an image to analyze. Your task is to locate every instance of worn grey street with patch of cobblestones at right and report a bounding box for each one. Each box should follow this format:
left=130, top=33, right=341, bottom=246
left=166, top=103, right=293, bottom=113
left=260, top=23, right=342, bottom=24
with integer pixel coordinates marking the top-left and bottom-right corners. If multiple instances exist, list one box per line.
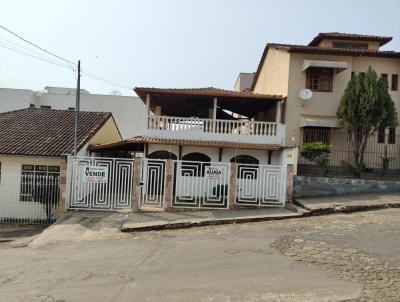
left=0, top=209, right=400, bottom=302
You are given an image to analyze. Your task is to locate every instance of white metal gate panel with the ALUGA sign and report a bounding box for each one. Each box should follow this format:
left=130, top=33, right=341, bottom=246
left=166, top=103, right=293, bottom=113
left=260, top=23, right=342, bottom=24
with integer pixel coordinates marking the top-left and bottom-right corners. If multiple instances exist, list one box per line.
left=172, top=160, right=230, bottom=209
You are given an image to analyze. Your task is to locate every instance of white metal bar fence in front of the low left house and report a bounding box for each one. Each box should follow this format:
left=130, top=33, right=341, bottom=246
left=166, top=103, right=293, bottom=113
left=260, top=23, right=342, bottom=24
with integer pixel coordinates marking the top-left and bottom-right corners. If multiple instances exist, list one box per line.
left=0, top=173, right=60, bottom=224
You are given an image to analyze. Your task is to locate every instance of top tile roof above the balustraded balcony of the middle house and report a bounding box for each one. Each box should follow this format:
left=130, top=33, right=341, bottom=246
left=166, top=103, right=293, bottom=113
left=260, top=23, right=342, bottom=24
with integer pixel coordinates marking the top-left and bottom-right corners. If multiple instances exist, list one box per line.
left=134, top=87, right=284, bottom=102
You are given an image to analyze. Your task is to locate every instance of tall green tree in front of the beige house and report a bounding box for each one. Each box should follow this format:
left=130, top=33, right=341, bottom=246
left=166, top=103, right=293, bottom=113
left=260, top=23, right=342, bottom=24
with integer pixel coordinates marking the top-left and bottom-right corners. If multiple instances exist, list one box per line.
left=337, top=66, right=398, bottom=174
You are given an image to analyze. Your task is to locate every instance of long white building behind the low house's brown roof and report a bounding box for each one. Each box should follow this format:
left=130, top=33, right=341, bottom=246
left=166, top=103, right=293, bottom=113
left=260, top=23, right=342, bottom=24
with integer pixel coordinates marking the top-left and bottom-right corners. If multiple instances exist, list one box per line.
left=0, top=86, right=146, bottom=138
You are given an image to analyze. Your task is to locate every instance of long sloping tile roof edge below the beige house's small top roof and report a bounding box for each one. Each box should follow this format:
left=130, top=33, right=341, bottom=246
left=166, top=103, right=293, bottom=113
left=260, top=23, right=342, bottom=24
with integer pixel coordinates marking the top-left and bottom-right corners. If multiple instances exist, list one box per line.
left=251, top=43, right=400, bottom=90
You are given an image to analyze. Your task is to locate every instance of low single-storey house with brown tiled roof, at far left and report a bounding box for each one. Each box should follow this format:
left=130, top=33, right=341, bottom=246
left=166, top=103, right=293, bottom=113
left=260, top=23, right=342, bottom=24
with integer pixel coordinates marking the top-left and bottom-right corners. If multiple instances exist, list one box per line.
left=0, top=108, right=121, bottom=222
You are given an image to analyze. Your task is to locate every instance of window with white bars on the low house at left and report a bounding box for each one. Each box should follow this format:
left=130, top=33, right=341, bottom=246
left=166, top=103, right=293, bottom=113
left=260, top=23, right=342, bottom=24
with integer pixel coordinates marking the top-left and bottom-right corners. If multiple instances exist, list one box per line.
left=19, top=165, right=60, bottom=203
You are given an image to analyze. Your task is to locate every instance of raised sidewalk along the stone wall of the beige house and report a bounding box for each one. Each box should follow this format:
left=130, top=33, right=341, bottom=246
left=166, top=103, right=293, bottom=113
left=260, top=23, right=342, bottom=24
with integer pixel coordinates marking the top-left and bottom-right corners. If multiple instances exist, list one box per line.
left=295, top=192, right=400, bottom=215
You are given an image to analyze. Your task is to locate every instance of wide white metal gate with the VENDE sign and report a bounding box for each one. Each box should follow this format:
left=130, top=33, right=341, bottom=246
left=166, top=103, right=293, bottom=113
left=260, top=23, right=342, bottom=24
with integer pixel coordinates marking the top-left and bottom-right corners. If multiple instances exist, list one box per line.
left=68, top=157, right=134, bottom=211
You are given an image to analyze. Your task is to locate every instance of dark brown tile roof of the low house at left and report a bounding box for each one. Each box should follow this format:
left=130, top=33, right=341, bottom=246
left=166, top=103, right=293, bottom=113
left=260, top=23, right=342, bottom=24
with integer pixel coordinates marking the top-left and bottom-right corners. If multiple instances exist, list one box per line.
left=0, top=108, right=112, bottom=156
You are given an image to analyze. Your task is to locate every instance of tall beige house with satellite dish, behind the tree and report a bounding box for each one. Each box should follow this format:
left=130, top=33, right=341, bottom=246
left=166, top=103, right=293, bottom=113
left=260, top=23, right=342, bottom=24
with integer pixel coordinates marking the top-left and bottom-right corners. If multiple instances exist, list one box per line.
left=250, top=33, right=400, bottom=145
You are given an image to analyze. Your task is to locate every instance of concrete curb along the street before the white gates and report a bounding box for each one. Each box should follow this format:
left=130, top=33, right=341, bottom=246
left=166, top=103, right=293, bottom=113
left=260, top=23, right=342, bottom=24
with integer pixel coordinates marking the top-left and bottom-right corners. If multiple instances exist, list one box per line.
left=121, top=213, right=303, bottom=233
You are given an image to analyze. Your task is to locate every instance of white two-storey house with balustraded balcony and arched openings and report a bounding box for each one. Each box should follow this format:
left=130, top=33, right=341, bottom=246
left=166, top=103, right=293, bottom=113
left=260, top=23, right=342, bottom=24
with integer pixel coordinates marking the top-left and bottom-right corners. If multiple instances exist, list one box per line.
left=90, top=87, right=291, bottom=209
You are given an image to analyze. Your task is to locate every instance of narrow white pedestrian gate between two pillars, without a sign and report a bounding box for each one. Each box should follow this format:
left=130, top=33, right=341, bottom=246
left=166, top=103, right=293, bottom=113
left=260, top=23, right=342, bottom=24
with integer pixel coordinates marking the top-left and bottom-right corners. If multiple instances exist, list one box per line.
left=140, top=158, right=167, bottom=208
